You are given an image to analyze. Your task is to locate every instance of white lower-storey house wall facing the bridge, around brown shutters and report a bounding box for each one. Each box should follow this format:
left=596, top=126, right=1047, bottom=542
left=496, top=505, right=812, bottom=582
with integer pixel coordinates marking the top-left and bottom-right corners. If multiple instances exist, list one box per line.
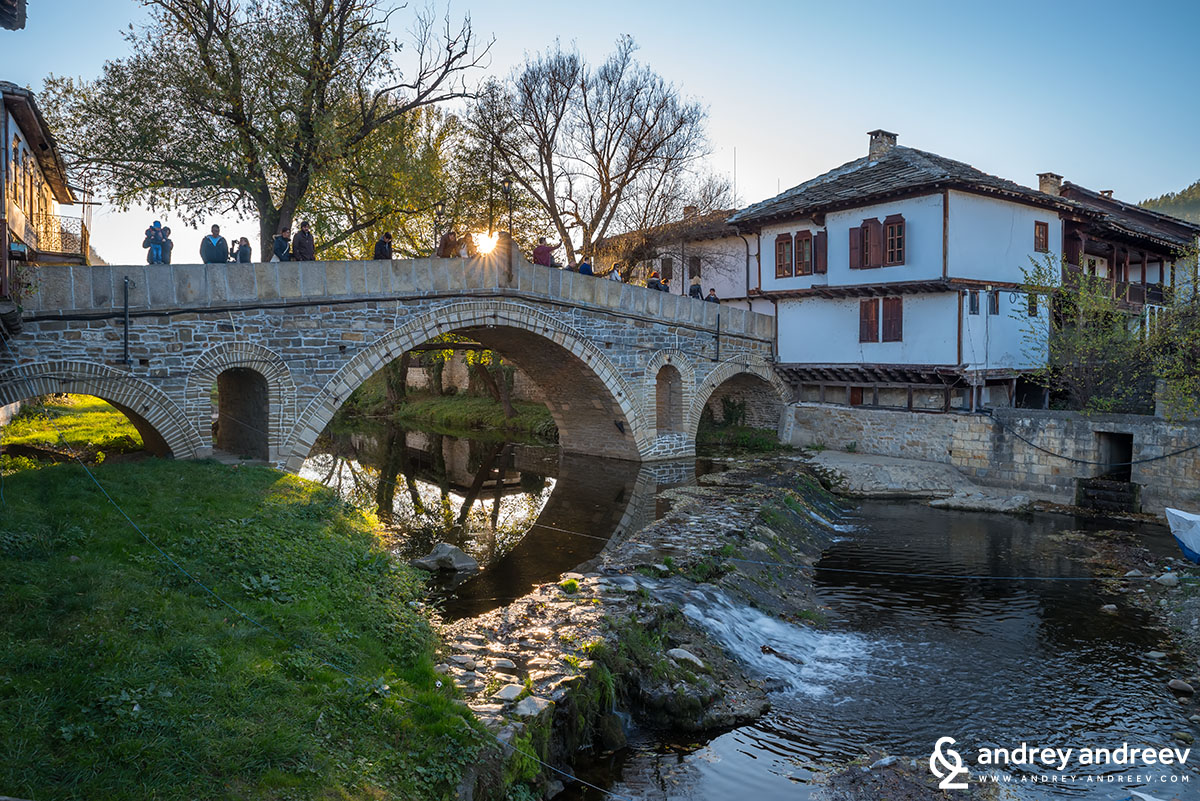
left=779, top=292, right=959, bottom=365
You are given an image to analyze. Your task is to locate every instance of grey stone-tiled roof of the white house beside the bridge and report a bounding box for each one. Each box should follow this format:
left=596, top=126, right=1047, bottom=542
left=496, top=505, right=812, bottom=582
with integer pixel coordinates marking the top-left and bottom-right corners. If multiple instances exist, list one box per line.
left=728, top=145, right=1078, bottom=224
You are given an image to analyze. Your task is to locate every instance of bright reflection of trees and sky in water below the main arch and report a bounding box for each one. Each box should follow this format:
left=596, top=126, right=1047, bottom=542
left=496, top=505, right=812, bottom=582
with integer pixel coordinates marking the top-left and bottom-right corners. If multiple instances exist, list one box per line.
left=301, top=424, right=554, bottom=565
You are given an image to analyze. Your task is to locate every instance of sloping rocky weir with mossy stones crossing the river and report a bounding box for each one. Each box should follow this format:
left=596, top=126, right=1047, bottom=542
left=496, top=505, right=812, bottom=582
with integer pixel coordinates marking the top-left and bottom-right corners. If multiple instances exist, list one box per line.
left=438, top=457, right=839, bottom=799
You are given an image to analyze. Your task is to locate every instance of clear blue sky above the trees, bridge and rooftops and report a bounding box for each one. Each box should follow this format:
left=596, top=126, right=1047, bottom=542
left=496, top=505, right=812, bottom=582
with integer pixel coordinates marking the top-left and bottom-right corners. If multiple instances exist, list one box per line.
left=0, top=0, right=1200, bottom=261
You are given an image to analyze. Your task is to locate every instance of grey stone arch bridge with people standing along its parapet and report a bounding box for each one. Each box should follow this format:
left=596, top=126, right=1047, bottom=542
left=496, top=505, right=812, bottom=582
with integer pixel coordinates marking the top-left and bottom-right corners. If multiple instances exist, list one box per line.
left=0, top=253, right=790, bottom=471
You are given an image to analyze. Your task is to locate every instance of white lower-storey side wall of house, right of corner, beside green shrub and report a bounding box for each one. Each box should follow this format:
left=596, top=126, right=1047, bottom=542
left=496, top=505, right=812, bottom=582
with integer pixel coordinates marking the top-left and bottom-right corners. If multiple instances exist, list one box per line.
left=962, top=289, right=1049, bottom=371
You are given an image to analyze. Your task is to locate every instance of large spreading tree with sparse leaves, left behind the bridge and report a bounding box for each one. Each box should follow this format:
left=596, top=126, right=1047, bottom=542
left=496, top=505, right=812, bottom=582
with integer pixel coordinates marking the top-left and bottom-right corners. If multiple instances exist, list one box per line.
left=42, top=0, right=490, bottom=253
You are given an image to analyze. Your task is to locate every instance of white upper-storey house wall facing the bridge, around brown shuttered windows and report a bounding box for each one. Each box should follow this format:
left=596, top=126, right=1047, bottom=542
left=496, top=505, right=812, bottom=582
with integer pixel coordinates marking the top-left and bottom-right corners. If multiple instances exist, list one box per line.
left=758, top=193, right=942, bottom=293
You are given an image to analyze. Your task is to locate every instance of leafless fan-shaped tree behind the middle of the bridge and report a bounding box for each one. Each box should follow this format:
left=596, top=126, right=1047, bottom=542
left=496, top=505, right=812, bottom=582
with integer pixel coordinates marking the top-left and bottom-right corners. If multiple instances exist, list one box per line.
left=469, top=36, right=708, bottom=266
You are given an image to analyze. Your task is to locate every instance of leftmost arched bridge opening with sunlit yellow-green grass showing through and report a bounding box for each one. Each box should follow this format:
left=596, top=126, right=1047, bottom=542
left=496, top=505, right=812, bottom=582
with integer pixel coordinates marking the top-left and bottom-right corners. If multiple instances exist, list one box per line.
left=0, top=392, right=172, bottom=462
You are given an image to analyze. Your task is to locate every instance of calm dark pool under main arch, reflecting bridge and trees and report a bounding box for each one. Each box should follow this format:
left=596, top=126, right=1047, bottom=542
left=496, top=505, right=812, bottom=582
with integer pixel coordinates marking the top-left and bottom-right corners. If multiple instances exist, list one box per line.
left=302, top=426, right=695, bottom=618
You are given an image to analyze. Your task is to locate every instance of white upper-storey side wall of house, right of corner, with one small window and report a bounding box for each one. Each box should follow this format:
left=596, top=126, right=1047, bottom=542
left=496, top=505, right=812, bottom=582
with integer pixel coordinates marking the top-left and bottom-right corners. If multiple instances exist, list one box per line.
left=947, top=191, right=1062, bottom=283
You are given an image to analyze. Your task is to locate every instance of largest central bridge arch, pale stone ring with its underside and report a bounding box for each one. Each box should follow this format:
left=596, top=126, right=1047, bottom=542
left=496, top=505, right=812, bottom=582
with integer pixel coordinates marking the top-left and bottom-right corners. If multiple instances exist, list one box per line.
left=278, top=300, right=654, bottom=472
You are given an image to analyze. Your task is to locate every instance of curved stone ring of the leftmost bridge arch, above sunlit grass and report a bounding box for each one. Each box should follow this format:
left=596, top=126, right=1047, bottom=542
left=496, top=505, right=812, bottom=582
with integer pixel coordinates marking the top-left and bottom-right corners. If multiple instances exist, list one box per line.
left=0, top=361, right=203, bottom=458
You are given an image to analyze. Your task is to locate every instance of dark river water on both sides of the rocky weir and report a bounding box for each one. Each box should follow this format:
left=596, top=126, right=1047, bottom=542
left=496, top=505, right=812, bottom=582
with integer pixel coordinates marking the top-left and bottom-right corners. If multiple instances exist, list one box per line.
left=306, top=429, right=1200, bottom=801
